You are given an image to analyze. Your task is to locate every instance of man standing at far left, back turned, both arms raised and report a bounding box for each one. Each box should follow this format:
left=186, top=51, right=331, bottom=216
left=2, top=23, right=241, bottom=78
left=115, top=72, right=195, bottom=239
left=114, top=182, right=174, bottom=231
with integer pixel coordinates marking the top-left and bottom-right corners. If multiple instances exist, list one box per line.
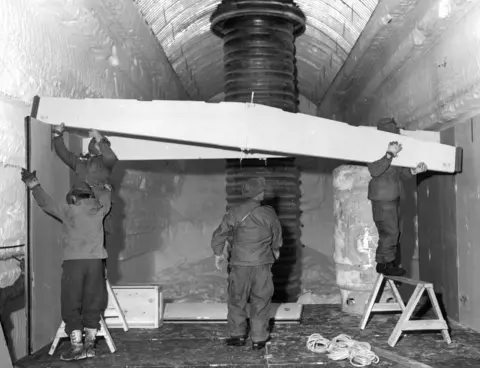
left=21, top=169, right=111, bottom=361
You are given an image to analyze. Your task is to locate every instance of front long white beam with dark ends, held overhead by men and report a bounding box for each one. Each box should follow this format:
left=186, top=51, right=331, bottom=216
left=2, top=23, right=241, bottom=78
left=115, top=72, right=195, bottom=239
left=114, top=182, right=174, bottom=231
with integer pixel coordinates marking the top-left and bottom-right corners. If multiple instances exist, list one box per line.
left=37, top=97, right=461, bottom=173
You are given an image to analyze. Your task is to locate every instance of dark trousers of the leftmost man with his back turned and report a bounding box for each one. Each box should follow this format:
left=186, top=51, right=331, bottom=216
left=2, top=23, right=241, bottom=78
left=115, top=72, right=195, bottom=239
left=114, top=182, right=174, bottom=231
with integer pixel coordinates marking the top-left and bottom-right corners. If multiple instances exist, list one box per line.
left=61, top=259, right=108, bottom=335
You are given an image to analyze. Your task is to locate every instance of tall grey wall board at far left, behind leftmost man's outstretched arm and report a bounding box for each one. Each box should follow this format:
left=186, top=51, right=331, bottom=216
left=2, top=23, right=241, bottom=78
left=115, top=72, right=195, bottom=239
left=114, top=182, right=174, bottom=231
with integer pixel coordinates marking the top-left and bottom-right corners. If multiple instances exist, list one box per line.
left=27, top=121, right=70, bottom=351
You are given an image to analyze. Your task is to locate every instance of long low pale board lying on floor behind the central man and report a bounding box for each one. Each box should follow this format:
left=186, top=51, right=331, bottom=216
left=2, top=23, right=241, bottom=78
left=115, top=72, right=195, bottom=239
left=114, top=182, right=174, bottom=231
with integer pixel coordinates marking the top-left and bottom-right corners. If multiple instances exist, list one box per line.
left=163, top=303, right=303, bottom=321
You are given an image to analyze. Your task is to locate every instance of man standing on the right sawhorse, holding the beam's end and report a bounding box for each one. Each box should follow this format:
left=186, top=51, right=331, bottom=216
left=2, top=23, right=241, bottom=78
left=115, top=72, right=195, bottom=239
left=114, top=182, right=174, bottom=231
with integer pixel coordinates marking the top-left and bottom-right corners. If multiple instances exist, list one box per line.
left=368, top=118, right=427, bottom=276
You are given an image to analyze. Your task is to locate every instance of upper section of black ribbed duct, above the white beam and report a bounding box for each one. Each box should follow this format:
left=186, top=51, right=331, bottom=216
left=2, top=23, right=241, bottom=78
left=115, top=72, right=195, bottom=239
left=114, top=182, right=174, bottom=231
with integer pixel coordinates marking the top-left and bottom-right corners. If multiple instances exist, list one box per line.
left=211, top=0, right=305, bottom=112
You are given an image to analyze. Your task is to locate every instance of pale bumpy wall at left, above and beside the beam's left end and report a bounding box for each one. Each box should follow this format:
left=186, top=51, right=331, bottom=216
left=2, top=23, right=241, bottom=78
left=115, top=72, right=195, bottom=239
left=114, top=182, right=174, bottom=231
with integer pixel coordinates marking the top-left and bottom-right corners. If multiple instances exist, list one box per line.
left=0, top=0, right=186, bottom=360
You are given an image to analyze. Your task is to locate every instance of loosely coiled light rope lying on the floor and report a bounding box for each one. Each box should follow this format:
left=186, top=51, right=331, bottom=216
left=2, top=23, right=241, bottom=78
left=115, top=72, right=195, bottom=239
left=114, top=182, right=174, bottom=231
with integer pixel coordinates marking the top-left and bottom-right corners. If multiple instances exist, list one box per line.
left=307, top=334, right=380, bottom=367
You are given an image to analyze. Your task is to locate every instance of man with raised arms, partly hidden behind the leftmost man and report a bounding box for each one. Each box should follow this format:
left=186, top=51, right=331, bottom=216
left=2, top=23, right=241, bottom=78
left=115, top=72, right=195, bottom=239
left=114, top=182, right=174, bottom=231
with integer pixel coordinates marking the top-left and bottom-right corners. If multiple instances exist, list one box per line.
left=53, top=123, right=118, bottom=197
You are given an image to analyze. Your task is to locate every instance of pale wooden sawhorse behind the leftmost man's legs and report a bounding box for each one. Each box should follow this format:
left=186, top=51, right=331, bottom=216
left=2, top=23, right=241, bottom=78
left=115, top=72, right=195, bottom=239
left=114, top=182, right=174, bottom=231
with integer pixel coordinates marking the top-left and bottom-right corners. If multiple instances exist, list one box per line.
left=48, top=280, right=128, bottom=355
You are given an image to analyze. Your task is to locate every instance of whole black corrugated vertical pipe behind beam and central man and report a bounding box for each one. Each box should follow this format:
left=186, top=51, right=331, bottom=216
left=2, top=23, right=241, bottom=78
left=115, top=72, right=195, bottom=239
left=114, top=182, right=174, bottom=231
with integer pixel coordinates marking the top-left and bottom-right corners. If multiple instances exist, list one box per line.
left=210, top=0, right=305, bottom=302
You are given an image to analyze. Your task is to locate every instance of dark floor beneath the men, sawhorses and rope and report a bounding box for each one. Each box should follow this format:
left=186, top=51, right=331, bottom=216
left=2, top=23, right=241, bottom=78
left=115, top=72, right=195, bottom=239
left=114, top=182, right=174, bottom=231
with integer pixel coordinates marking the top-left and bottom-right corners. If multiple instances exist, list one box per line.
left=15, top=305, right=480, bottom=368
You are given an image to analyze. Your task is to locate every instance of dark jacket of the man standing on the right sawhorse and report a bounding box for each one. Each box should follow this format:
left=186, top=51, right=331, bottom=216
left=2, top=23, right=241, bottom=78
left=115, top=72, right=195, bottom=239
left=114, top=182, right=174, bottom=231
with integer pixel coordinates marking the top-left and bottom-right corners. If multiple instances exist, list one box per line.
left=368, top=155, right=413, bottom=201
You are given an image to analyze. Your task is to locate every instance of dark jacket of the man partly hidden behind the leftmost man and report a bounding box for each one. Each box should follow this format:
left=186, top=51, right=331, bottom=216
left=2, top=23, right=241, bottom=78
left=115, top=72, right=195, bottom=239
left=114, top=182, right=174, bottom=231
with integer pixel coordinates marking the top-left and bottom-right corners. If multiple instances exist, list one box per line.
left=53, top=135, right=118, bottom=187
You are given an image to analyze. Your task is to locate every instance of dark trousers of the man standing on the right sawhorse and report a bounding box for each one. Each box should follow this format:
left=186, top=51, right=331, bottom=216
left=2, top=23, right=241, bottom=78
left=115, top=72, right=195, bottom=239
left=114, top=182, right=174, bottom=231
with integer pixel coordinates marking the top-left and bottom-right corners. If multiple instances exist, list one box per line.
left=372, top=199, right=400, bottom=263
